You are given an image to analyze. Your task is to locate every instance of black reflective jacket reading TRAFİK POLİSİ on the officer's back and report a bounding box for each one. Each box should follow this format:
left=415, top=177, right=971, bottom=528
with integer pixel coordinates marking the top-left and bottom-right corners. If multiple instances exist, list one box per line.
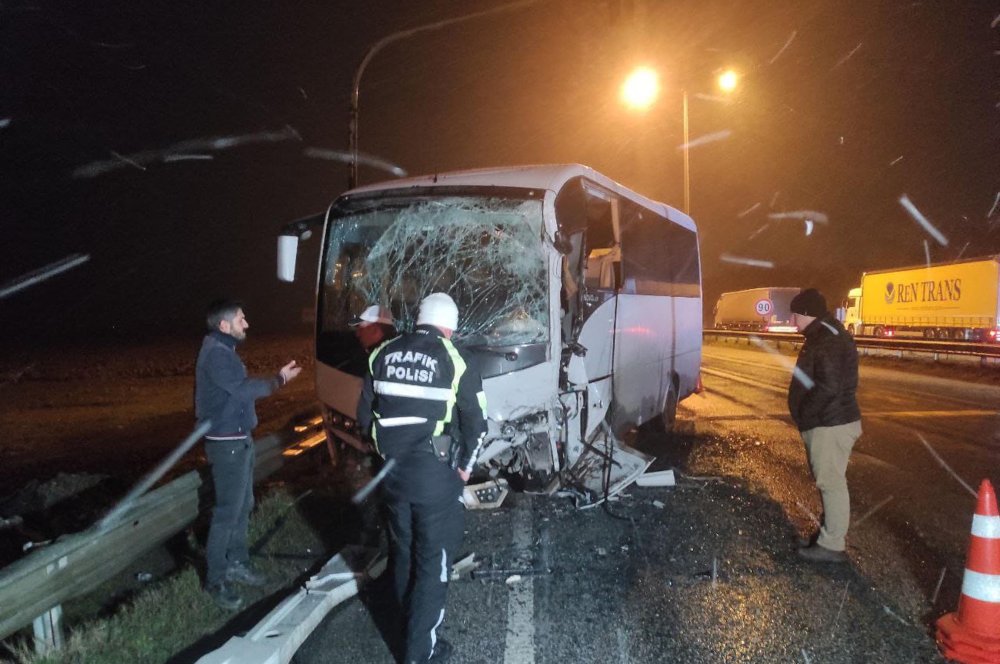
left=357, top=325, right=486, bottom=472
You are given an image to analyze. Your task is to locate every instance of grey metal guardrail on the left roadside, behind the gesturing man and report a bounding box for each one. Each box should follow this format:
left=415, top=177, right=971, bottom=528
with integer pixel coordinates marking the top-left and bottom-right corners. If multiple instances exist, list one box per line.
left=0, top=420, right=325, bottom=639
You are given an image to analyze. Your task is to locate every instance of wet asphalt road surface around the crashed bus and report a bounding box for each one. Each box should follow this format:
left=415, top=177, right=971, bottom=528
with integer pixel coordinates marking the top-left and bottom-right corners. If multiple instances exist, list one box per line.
left=293, top=346, right=1000, bottom=664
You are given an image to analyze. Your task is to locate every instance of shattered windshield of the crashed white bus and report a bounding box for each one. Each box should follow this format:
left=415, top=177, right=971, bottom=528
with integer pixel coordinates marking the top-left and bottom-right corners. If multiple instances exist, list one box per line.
left=320, top=195, right=549, bottom=346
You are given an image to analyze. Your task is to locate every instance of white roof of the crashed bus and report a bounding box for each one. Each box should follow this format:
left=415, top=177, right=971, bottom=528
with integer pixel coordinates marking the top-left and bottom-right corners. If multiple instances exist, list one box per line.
left=345, top=164, right=695, bottom=230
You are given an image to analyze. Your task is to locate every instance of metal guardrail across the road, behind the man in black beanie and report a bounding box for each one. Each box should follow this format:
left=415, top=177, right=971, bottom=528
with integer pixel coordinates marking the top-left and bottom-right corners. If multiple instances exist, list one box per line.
left=702, top=329, right=1000, bottom=368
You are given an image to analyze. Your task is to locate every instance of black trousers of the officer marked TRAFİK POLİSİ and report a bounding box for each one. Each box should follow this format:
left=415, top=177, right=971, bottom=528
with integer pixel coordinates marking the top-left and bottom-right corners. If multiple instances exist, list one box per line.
left=386, top=491, right=465, bottom=664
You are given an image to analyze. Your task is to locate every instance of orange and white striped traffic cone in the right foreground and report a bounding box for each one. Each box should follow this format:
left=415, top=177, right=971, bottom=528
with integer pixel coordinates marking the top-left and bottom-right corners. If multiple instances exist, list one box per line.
left=937, top=480, right=1000, bottom=664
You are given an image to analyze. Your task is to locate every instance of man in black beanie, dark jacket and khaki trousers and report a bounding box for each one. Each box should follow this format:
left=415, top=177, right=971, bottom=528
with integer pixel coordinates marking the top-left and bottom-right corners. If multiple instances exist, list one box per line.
left=788, top=288, right=861, bottom=562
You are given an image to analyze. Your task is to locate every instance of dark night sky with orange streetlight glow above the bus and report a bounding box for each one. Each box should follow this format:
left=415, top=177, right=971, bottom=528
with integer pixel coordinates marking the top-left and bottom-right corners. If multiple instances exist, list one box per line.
left=0, top=0, right=1000, bottom=337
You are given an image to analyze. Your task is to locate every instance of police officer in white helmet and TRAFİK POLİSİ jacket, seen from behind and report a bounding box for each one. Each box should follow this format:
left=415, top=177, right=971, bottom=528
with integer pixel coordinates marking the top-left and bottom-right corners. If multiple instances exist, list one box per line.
left=357, top=293, right=486, bottom=664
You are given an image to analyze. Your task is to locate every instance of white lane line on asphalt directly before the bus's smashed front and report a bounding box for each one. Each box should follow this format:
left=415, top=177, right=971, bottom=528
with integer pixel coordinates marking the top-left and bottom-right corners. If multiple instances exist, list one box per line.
left=503, top=495, right=535, bottom=664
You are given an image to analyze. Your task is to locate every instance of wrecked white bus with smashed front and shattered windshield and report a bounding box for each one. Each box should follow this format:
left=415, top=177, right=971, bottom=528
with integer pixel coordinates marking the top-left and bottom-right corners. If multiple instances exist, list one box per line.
left=278, top=165, right=702, bottom=504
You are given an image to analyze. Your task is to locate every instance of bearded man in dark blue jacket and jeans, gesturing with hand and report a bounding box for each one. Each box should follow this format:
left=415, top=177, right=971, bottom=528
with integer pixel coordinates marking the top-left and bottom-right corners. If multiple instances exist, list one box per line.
left=194, top=300, right=302, bottom=611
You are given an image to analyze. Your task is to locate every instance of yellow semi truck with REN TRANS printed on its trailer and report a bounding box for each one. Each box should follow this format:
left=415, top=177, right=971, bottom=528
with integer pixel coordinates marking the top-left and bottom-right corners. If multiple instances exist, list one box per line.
left=844, top=256, right=1000, bottom=342
